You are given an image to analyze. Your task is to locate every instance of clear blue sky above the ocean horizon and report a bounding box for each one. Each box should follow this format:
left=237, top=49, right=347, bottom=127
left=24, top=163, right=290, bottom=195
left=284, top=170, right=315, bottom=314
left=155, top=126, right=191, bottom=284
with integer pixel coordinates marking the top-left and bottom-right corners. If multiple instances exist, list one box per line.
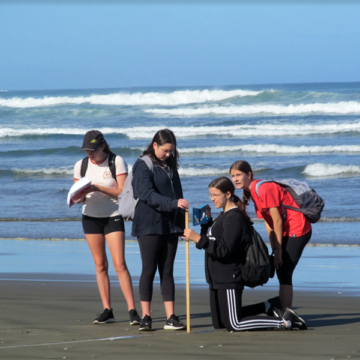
left=0, top=2, right=360, bottom=90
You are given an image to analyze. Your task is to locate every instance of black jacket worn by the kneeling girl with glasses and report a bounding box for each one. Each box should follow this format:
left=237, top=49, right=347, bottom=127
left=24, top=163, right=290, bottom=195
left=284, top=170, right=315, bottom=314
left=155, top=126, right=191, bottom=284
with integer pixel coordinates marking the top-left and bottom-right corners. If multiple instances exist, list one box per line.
left=196, top=208, right=251, bottom=289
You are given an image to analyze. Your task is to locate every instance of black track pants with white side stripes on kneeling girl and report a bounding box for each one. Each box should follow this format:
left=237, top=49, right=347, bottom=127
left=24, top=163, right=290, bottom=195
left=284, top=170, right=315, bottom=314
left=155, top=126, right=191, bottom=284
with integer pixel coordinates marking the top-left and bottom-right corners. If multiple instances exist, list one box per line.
left=210, top=289, right=284, bottom=331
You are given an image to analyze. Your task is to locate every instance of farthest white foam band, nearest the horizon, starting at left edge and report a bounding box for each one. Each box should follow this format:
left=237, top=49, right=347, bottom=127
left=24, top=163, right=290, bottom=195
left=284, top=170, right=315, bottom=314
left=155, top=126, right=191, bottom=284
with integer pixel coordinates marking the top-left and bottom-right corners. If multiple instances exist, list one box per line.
left=0, top=90, right=262, bottom=108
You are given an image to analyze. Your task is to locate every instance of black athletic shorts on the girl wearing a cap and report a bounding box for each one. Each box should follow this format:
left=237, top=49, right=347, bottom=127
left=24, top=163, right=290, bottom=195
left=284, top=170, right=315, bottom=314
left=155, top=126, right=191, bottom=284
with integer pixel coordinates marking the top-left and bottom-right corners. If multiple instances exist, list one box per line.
left=82, top=215, right=125, bottom=235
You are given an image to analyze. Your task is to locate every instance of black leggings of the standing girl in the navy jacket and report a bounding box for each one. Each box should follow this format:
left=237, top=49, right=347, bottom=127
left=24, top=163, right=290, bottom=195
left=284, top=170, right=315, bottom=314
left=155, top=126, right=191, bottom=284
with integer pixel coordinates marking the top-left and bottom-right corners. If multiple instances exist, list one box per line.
left=138, top=234, right=179, bottom=301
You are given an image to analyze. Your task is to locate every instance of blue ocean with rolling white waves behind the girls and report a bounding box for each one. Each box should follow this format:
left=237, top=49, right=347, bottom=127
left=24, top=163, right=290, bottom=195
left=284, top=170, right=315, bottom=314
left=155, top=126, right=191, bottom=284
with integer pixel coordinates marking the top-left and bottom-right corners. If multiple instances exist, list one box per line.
left=0, top=83, right=360, bottom=244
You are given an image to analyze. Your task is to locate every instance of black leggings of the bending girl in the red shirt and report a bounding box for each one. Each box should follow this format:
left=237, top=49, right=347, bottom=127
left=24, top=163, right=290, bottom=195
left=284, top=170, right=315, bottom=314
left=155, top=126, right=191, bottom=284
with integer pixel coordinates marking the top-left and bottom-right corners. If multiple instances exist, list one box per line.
left=276, top=230, right=311, bottom=285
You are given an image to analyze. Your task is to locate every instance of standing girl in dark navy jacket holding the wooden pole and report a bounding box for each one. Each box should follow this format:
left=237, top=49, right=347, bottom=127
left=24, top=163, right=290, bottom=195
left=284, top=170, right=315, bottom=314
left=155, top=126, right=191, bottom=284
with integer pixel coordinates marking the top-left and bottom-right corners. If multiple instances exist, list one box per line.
left=132, top=129, right=189, bottom=330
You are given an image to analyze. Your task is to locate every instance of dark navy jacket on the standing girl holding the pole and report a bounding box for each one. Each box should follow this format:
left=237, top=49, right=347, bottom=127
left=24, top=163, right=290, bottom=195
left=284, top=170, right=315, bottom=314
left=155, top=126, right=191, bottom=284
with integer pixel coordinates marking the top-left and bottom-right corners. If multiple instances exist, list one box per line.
left=131, top=159, right=185, bottom=236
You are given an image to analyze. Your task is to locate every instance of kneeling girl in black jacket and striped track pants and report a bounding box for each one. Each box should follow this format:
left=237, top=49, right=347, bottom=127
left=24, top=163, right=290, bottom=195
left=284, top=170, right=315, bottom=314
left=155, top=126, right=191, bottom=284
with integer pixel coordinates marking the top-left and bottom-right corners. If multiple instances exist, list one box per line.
left=183, top=177, right=303, bottom=331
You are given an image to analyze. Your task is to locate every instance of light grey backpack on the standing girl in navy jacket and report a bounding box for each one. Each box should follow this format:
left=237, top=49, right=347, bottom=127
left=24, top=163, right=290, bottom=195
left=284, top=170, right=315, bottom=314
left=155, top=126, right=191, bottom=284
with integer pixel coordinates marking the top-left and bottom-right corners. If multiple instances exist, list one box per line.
left=118, top=155, right=154, bottom=221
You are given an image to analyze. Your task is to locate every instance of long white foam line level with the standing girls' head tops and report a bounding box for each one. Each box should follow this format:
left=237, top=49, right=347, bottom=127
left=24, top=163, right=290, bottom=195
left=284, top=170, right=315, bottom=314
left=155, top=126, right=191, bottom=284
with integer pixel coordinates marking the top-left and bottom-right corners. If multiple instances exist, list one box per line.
left=0, top=121, right=360, bottom=139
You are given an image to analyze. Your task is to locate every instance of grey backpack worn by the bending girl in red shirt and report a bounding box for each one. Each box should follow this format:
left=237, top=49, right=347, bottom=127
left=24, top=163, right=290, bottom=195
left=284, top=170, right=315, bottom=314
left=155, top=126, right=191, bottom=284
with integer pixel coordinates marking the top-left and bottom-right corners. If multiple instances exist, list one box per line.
left=255, top=179, right=325, bottom=223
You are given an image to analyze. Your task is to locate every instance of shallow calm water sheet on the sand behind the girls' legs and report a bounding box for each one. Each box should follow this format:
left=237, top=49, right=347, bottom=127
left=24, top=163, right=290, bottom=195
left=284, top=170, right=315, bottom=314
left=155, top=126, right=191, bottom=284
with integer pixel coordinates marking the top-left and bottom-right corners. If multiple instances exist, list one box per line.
left=0, top=240, right=360, bottom=296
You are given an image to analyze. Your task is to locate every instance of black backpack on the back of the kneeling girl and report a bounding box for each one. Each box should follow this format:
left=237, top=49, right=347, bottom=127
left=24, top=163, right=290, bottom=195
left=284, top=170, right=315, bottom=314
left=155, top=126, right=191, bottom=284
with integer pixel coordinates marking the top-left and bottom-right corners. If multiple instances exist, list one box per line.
left=241, top=223, right=274, bottom=288
